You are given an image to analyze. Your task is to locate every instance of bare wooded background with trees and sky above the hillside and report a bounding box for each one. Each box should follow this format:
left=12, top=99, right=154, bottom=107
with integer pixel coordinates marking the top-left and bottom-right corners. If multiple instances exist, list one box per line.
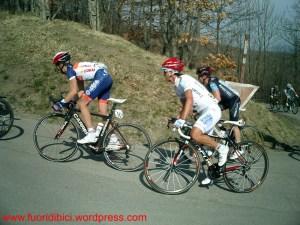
left=0, top=0, right=300, bottom=99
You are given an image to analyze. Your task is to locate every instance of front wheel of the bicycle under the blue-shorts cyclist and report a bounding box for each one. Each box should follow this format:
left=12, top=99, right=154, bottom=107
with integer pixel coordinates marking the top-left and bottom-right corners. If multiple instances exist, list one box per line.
left=33, top=113, right=79, bottom=162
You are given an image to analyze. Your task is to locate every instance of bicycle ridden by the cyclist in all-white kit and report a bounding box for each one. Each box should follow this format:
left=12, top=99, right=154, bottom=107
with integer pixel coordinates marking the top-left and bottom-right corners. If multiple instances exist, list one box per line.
left=144, top=119, right=269, bottom=194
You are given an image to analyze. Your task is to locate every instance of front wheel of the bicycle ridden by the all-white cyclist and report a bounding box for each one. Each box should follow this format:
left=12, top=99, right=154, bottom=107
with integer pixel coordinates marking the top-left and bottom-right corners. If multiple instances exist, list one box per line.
left=145, top=139, right=200, bottom=195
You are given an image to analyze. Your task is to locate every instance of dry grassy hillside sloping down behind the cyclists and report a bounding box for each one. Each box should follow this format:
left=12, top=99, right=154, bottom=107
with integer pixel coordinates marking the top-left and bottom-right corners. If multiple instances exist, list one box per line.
left=0, top=12, right=300, bottom=145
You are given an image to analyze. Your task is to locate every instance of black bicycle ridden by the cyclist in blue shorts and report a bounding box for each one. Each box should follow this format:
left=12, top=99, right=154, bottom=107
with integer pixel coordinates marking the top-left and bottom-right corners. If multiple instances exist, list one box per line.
left=33, top=98, right=151, bottom=171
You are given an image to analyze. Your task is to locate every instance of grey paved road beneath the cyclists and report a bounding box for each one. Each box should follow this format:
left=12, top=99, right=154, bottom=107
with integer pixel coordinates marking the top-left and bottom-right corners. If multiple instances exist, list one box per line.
left=0, top=117, right=300, bottom=225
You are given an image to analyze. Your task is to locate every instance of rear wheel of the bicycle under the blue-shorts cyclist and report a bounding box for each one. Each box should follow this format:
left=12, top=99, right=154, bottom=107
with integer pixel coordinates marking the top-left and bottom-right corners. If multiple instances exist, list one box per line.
left=102, top=123, right=151, bottom=171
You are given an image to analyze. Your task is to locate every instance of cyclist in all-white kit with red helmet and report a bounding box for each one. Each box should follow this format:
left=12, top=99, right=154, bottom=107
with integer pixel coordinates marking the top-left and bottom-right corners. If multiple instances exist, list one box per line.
left=161, top=57, right=229, bottom=184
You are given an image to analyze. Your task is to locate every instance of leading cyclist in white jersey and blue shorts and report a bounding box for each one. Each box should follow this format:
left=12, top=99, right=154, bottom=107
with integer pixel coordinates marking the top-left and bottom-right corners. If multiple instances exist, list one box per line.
left=52, top=52, right=113, bottom=144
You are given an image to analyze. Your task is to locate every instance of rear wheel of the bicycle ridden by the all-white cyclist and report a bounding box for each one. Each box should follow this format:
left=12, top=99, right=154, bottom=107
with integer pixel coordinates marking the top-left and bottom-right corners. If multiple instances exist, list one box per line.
left=223, top=141, right=269, bottom=193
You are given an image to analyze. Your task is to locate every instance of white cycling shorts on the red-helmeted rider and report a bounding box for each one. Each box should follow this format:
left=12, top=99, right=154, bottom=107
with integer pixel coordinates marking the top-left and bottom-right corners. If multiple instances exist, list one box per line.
left=194, top=106, right=222, bottom=134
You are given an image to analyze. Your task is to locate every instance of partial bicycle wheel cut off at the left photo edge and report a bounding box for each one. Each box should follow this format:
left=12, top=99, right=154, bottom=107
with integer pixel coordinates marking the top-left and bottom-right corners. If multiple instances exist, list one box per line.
left=0, top=96, right=14, bottom=137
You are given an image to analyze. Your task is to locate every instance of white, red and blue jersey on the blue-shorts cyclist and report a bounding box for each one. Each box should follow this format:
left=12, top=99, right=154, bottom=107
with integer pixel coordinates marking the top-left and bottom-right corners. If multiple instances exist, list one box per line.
left=67, top=62, right=107, bottom=80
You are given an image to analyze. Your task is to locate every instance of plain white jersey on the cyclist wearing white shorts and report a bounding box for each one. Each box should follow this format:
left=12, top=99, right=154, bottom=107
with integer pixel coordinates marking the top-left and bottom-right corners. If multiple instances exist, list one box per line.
left=175, top=74, right=219, bottom=113
